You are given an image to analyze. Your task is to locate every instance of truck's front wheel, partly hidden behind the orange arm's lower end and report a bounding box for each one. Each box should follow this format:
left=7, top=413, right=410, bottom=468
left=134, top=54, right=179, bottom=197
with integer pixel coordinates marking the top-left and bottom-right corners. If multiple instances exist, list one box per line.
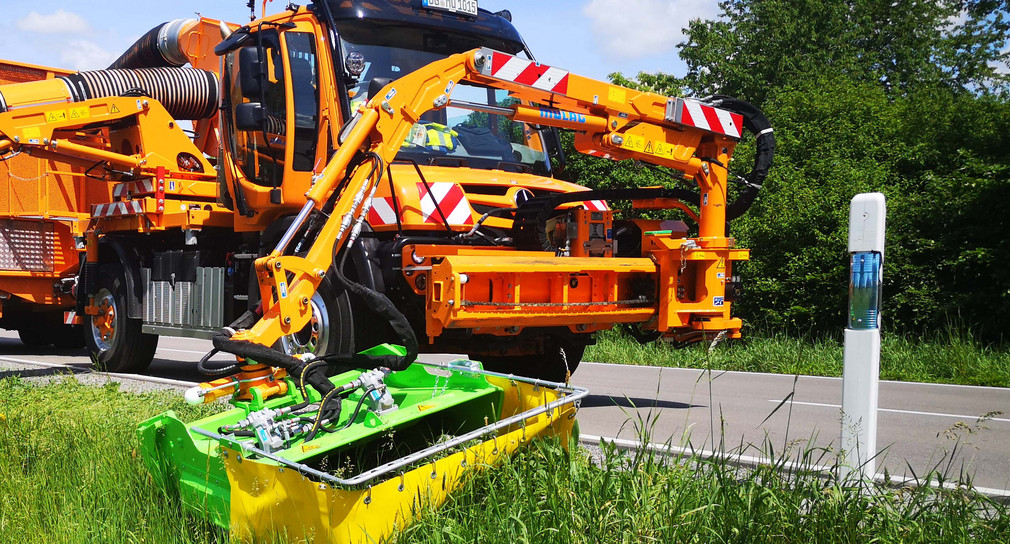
left=275, top=277, right=355, bottom=356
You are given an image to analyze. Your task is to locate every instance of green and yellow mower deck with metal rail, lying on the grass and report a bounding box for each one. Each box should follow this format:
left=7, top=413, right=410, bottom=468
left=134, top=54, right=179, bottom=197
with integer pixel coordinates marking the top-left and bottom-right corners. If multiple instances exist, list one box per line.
left=139, top=361, right=587, bottom=543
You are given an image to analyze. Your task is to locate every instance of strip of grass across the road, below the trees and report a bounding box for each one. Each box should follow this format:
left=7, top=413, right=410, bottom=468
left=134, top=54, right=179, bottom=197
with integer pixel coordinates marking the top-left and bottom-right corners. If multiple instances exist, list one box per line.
left=583, top=331, right=1010, bottom=388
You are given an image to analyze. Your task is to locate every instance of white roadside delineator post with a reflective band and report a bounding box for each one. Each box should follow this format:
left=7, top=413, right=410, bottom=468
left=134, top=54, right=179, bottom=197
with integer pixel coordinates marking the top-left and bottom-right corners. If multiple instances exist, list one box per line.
left=838, top=193, right=887, bottom=478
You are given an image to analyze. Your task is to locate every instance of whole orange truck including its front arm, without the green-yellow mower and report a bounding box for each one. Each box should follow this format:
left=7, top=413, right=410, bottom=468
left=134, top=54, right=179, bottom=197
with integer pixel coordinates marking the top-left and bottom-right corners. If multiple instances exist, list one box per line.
left=0, top=0, right=774, bottom=380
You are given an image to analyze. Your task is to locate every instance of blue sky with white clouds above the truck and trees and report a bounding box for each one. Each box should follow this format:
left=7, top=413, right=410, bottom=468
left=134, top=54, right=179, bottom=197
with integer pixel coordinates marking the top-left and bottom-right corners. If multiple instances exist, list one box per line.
left=0, top=0, right=718, bottom=80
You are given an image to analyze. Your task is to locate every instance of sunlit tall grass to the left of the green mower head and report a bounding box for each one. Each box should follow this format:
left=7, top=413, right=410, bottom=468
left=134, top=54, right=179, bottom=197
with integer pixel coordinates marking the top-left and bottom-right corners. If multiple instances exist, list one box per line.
left=0, top=376, right=227, bottom=544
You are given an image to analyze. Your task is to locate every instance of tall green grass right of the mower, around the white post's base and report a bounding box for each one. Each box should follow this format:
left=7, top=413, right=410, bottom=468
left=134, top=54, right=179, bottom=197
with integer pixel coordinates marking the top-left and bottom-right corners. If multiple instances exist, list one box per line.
left=396, top=442, right=1010, bottom=544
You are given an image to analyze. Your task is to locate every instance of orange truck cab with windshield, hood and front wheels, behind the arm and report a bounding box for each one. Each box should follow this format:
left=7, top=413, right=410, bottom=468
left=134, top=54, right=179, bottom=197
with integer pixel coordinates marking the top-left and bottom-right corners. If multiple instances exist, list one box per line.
left=217, top=0, right=606, bottom=376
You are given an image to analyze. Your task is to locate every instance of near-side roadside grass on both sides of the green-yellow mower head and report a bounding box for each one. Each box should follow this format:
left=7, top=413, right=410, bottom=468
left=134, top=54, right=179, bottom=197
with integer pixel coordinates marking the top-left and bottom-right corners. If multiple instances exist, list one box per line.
left=0, top=376, right=1010, bottom=544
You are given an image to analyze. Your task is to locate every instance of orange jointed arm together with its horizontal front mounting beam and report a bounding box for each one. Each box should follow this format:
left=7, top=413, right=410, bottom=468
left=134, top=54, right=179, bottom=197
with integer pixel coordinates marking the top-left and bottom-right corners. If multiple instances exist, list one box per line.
left=234, top=48, right=770, bottom=353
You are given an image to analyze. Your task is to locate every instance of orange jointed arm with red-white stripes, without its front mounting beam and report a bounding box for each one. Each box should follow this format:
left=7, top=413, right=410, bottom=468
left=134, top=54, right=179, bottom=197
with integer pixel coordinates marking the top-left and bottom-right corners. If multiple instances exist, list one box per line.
left=235, top=48, right=742, bottom=345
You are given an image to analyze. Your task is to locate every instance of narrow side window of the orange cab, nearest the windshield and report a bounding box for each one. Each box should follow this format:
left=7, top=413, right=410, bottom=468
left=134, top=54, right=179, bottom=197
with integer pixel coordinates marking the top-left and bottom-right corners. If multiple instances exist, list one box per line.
left=285, top=32, right=319, bottom=172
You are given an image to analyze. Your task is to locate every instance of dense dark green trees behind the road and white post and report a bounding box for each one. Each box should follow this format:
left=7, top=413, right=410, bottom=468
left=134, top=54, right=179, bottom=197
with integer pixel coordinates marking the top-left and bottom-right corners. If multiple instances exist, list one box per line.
left=557, top=0, right=1010, bottom=338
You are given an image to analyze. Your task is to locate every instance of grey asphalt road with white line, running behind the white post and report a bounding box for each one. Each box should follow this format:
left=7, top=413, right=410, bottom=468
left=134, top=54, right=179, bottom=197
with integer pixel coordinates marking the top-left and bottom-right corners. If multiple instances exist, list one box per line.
left=0, top=331, right=1010, bottom=491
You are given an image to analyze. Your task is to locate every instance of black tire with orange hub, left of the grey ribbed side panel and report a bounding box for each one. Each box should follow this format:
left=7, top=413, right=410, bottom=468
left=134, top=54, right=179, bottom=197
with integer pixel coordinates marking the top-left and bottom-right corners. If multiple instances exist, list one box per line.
left=84, top=264, right=158, bottom=373
